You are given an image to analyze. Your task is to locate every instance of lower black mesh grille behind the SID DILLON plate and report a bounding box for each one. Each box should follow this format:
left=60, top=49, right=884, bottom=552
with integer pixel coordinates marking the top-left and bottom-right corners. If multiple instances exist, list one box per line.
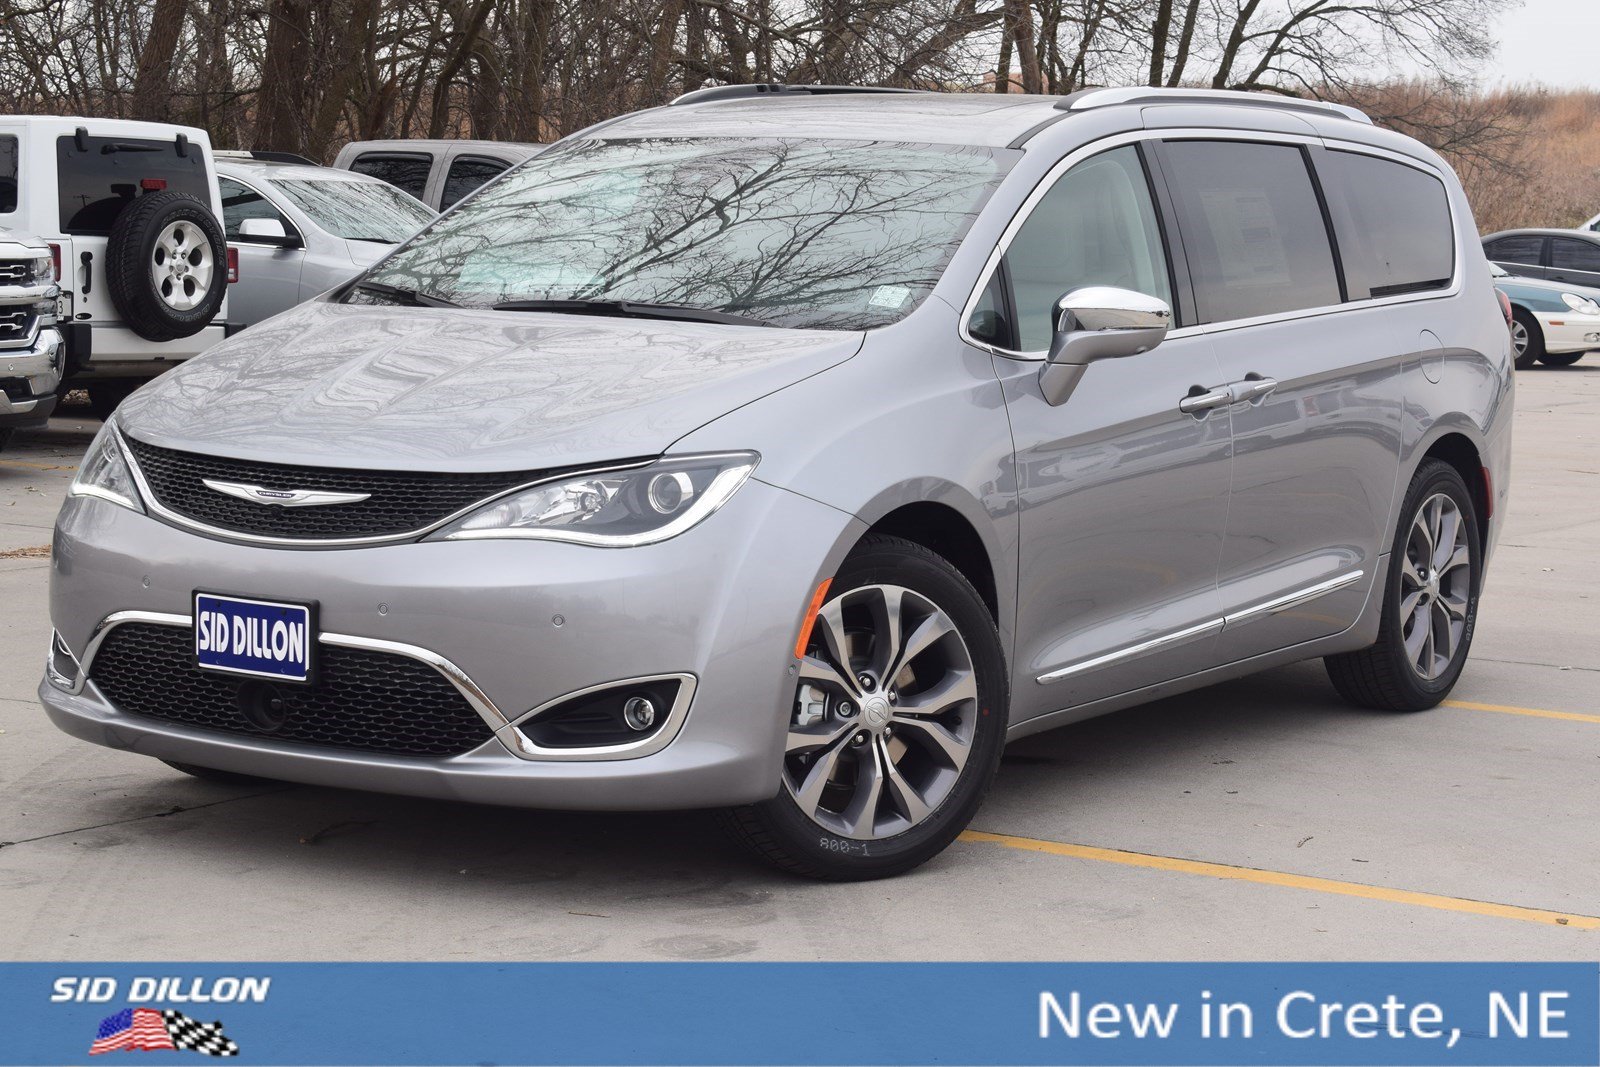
left=90, top=622, right=493, bottom=757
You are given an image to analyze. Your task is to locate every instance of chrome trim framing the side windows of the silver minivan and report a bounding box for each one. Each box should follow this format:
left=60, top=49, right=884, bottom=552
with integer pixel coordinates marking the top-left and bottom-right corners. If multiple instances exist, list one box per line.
left=957, top=126, right=1466, bottom=362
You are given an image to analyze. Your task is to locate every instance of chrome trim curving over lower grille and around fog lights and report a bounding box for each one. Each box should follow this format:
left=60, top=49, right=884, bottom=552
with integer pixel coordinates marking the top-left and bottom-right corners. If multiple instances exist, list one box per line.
left=45, top=611, right=696, bottom=761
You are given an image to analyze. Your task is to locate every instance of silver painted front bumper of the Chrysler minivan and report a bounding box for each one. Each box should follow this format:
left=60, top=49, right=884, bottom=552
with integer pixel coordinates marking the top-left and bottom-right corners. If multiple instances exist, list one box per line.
left=38, top=478, right=862, bottom=809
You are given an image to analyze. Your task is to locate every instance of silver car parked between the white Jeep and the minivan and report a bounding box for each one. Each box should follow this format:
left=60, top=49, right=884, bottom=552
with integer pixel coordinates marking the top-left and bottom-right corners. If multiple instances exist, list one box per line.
left=216, top=152, right=438, bottom=326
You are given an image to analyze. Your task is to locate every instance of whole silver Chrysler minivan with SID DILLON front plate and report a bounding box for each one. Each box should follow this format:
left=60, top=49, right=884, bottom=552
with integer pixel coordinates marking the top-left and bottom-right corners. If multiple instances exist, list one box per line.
left=40, top=86, right=1512, bottom=878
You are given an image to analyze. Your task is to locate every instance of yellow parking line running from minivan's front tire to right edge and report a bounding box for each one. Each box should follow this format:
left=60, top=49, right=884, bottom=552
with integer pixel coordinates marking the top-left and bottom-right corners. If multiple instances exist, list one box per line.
left=960, top=830, right=1600, bottom=929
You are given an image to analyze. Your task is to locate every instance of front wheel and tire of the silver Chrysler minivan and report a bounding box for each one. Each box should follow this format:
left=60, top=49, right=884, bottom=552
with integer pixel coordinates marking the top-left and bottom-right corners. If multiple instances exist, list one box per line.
left=726, top=537, right=1006, bottom=880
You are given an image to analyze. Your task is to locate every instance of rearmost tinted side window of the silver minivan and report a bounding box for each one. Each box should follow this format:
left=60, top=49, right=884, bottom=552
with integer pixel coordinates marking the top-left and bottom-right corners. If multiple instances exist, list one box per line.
left=1317, top=152, right=1456, bottom=301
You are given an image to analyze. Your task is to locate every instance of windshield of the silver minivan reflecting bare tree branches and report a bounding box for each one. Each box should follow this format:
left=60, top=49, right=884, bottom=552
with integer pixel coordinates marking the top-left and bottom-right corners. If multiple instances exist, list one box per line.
left=357, top=138, right=1018, bottom=330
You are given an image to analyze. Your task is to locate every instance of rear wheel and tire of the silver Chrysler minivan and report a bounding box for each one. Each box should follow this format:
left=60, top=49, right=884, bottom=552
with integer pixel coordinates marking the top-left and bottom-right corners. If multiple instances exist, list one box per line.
left=1325, top=459, right=1482, bottom=712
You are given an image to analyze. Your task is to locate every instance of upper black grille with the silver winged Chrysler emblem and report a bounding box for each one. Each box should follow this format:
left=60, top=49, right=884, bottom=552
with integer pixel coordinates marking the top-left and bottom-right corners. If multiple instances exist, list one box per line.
left=125, top=437, right=555, bottom=541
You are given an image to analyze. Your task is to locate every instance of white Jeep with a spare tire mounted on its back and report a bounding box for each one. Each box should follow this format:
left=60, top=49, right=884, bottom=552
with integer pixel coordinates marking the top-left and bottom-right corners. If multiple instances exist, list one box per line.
left=0, top=115, right=230, bottom=418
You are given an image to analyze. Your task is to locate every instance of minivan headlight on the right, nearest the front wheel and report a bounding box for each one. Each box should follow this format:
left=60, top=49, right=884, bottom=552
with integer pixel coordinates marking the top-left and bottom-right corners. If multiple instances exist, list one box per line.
left=434, top=453, right=760, bottom=549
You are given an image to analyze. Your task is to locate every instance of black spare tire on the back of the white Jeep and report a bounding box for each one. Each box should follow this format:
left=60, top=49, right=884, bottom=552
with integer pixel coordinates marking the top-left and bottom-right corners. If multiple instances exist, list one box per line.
left=106, top=190, right=227, bottom=341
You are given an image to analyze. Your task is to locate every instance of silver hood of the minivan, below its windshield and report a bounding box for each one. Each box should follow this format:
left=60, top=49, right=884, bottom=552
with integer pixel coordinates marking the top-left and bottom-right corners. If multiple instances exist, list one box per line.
left=117, top=302, right=862, bottom=472
